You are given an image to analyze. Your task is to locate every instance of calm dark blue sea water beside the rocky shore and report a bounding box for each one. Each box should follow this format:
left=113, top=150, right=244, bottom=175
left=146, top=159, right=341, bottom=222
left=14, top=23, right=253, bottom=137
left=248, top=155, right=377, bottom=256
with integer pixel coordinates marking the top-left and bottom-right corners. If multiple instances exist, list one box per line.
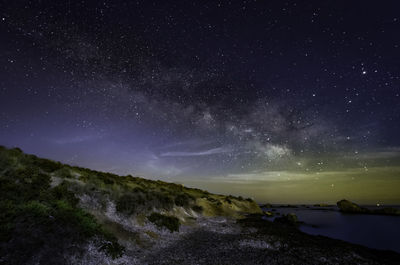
left=265, top=204, right=400, bottom=253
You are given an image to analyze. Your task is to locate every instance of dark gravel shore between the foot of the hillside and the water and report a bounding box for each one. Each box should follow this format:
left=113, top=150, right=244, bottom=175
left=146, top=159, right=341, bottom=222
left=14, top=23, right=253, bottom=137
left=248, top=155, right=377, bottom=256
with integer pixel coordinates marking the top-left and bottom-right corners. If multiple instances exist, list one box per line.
left=70, top=213, right=400, bottom=265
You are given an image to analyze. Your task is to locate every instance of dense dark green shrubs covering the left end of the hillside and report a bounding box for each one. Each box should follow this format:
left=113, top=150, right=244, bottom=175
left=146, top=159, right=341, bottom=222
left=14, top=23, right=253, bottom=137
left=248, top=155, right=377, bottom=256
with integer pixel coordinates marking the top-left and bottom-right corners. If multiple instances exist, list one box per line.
left=0, top=145, right=123, bottom=264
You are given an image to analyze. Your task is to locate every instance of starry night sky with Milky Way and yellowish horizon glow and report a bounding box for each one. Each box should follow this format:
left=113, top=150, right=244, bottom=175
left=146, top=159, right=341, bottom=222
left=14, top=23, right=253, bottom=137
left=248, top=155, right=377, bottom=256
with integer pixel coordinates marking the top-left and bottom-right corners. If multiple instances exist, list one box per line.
left=0, top=0, right=400, bottom=204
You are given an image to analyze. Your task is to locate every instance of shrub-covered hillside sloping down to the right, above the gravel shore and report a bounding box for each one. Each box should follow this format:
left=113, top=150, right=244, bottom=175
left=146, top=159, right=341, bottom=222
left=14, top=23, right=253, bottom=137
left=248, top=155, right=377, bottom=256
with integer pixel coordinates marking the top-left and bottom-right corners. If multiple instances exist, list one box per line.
left=0, top=147, right=261, bottom=264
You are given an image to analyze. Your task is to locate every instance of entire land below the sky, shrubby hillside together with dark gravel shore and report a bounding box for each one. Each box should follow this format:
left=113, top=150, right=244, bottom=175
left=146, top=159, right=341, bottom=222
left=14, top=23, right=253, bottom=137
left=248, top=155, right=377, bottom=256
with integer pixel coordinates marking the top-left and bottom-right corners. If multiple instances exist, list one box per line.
left=0, top=147, right=400, bottom=265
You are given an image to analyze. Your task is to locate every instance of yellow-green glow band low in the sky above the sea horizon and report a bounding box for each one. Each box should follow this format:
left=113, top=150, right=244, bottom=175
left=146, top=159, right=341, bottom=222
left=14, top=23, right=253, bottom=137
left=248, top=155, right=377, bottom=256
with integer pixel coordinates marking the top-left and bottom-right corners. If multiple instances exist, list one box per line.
left=182, top=167, right=400, bottom=204
